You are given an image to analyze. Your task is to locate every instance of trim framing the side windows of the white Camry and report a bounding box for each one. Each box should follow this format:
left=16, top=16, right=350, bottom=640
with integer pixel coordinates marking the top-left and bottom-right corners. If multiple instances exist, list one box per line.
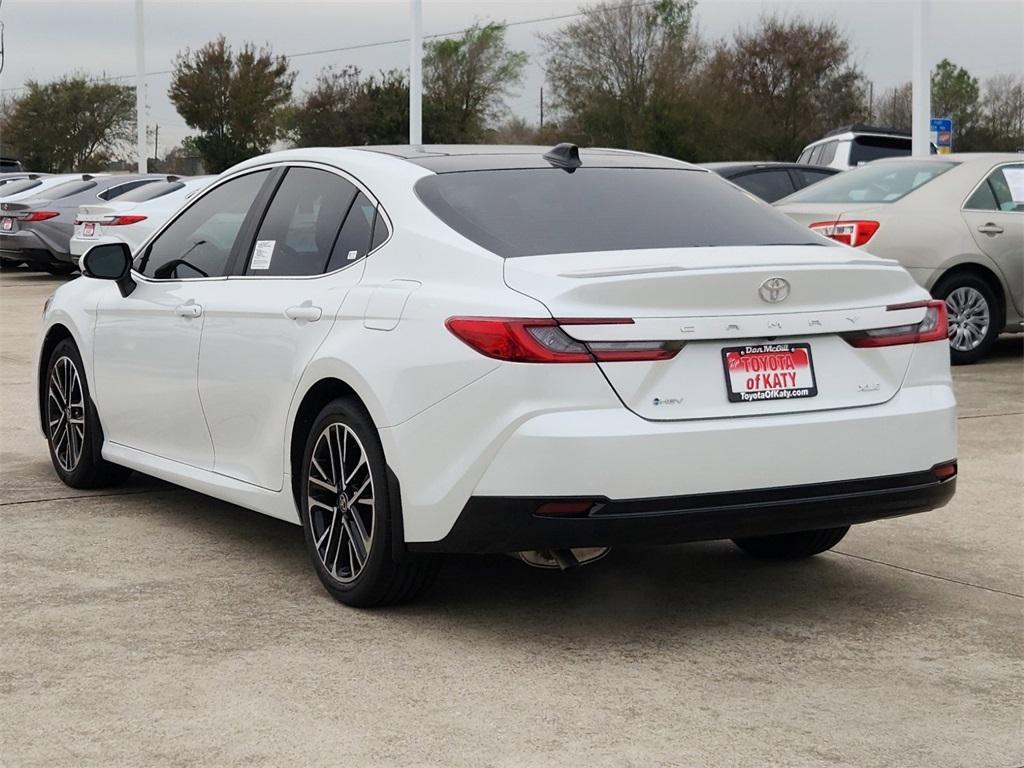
left=132, top=161, right=394, bottom=284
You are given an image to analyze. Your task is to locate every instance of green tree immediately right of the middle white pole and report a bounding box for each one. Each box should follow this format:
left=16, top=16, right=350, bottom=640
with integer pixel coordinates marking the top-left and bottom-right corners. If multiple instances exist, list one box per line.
left=423, top=24, right=527, bottom=143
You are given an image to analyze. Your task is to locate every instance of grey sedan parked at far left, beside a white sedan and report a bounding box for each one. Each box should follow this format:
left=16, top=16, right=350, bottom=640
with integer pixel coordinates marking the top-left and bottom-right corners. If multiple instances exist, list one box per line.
left=0, top=174, right=168, bottom=274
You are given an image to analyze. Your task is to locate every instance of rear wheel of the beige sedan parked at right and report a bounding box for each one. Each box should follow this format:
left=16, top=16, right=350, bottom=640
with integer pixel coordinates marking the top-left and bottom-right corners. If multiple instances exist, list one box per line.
left=933, top=272, right=1000, bottom=366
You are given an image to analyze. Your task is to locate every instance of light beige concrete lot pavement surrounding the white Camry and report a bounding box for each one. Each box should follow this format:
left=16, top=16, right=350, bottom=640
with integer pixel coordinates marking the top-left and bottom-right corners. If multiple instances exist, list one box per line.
left=0, top=271, right=1024, bottom=768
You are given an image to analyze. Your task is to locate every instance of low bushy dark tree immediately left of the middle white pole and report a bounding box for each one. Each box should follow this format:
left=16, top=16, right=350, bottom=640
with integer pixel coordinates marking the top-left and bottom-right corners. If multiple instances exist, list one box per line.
left=290, top=67, right=409, bottom=146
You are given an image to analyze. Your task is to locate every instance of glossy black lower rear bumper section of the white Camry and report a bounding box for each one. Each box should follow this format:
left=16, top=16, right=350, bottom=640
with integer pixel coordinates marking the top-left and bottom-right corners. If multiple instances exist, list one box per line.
left=409, top=465, right=956, bottom=553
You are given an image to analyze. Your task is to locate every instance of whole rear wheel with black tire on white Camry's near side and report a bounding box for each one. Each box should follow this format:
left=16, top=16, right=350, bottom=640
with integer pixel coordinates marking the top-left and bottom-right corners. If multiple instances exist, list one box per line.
left=298, top=398, right=439, bottom=607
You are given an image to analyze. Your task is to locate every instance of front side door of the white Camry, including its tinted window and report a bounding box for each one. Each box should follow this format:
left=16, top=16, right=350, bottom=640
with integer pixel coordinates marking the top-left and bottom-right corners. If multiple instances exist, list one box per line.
left=93, top=171, right=269, bottom=469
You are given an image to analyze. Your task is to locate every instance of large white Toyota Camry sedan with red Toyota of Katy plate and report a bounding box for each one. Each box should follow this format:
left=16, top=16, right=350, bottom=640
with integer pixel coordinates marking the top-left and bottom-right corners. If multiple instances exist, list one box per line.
left=38, top=144, right=956, bottom=605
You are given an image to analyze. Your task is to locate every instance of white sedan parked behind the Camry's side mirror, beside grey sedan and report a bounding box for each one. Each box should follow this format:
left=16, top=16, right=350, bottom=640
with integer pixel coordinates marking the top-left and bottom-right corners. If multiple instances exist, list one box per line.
left=71, top=176, right=214, bottom=258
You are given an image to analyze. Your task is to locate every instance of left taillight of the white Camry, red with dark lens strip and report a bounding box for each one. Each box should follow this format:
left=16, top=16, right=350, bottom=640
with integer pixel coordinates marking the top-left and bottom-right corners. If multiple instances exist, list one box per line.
left=444, top=317, right=683, bottom=362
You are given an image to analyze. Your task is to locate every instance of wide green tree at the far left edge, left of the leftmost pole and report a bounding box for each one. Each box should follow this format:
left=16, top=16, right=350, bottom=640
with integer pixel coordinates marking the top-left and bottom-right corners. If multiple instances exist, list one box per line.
left=0, top=75, right=135, bottom=172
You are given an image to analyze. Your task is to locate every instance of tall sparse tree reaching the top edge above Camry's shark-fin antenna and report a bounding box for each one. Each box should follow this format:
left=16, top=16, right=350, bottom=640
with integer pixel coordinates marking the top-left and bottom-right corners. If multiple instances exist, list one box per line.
left=541, top=0, right=700, bottom=157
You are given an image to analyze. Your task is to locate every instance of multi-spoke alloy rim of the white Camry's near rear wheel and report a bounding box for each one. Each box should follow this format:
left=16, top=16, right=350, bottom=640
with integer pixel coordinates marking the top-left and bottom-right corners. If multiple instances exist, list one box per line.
left=306, top=423, right=377, bottom=584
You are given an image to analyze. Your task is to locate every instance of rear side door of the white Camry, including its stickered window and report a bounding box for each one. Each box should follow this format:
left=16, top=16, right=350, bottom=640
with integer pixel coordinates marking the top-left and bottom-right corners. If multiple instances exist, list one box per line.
left=199, top=166, right=376, bottom=490
